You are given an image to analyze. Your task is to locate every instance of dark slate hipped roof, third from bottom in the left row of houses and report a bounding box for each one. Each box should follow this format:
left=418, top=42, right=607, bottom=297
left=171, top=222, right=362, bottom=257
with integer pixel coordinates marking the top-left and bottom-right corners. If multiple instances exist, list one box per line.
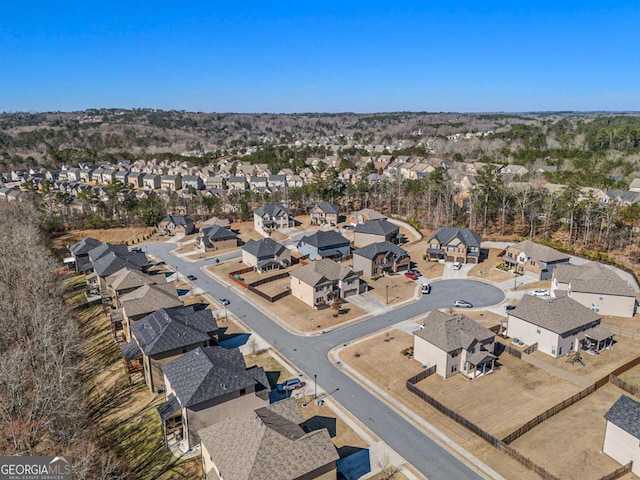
left=131, top=306, right=218, bottom=356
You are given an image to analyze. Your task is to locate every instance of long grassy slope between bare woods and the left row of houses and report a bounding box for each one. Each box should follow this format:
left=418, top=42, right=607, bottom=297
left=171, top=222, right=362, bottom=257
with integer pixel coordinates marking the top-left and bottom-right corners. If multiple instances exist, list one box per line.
left=69, top=276, right=201, bottom=480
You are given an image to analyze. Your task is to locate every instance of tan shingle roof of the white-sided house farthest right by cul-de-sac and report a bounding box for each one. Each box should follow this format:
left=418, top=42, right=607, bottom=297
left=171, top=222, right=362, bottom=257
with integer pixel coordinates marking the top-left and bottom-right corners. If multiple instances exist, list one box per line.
left=553, top=262, right=636, bottom=297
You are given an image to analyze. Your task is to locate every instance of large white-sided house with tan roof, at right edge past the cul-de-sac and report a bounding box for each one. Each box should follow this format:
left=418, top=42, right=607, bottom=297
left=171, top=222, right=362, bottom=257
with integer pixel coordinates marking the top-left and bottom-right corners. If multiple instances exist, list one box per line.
left=551, top=262, right=638, bottom=317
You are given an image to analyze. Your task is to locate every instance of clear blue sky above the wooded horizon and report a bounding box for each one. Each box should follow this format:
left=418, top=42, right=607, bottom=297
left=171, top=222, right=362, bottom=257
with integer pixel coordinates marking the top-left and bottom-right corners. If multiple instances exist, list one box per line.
left=0, top=0, right=640, bottom=112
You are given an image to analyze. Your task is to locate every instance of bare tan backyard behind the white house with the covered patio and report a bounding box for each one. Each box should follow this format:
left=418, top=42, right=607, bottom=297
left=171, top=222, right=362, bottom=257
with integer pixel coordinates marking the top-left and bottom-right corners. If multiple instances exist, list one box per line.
left=532, top=334, right=640, bottom=382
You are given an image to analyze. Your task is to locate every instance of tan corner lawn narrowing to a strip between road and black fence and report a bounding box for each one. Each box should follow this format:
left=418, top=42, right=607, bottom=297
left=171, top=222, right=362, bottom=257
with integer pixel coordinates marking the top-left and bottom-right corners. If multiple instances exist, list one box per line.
left=340, top=330, right=572, bottom=480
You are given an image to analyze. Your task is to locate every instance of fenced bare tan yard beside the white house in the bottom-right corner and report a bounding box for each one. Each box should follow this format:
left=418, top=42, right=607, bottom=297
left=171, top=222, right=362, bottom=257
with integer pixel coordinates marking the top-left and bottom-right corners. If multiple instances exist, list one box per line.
left=511, top=384, right=638, bottom=480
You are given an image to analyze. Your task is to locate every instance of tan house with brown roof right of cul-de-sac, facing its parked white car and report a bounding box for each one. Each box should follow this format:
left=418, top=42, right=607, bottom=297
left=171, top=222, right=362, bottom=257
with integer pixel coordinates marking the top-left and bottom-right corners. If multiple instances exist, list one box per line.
left=502, top=240, right=570, bottom=280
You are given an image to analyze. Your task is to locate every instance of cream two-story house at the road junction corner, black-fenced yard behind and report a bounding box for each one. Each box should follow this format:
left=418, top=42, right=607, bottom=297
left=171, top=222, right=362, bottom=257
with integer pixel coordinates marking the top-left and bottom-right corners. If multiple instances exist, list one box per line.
left=413, top=310, right=496, bottom=378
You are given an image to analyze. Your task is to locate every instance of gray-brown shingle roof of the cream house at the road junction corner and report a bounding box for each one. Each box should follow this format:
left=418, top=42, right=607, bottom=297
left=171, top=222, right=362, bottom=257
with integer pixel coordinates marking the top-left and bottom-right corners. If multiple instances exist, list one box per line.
left=414, top=310, right=495, bottom=352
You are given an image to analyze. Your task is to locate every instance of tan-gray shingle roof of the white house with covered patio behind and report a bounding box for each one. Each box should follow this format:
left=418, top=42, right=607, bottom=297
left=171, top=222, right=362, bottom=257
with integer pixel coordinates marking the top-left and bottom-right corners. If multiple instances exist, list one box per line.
left=509, top=295, right=602, bottom=335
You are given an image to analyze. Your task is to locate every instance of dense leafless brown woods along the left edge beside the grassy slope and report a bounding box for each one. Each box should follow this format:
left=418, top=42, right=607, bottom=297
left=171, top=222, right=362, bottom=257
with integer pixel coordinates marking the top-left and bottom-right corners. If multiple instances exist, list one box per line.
left=0, top=203, right=126, bottom=480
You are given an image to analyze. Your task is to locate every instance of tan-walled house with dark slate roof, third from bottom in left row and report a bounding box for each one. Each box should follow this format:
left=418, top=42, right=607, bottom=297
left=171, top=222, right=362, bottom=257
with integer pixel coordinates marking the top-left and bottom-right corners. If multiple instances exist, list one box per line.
left=122, top=305, right=218, bottom=392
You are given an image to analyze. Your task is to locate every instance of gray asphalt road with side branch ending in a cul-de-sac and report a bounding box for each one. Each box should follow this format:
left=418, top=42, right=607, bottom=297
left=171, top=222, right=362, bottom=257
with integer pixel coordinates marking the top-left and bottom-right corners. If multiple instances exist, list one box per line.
left=145, top=243, right=504, bottom=480
